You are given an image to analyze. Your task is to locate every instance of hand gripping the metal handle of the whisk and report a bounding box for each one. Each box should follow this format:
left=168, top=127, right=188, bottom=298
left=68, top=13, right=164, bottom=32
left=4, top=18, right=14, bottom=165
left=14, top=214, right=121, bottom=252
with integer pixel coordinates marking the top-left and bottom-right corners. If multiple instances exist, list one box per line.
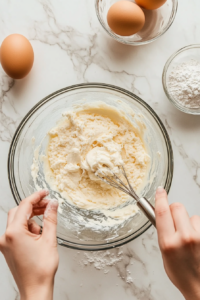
left=155, top=188, right=200, bottom=300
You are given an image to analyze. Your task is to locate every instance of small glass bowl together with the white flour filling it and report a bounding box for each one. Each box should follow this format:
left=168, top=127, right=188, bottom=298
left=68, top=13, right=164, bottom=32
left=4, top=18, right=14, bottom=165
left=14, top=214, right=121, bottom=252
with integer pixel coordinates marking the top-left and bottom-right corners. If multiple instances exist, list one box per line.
left=162, top=44, right=200, bottom=115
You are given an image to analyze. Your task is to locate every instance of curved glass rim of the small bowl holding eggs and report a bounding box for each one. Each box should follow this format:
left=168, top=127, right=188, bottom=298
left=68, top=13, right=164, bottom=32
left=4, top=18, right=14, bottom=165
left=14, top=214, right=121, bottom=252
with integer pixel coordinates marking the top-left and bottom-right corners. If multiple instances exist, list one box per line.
left=95, top=0, right=178, bottom=46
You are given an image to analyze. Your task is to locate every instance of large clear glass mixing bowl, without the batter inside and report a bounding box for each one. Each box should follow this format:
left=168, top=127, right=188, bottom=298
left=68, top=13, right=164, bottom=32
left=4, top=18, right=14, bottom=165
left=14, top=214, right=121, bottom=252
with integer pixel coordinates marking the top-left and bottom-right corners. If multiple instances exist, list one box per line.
left=8, top=83, right=173, bottom=250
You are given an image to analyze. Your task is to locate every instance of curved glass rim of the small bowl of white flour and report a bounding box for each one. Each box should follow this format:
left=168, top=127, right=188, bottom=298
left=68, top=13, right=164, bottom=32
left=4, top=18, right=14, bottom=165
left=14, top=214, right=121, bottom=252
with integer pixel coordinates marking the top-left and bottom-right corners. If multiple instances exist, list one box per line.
left=162, top=44, right=200, bottom=115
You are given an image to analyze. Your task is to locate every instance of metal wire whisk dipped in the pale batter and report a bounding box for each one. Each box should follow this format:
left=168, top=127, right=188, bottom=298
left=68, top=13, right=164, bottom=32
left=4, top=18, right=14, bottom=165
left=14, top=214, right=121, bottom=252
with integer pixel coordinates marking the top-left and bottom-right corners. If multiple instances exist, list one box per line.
left=96, top=166, right=156, bottom=227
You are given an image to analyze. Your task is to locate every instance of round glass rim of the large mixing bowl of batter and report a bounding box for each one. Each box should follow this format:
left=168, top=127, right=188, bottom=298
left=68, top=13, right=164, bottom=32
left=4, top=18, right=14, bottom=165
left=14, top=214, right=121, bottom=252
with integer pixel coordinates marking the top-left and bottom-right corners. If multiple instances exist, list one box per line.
left=7, top=82, right=174, bottom=251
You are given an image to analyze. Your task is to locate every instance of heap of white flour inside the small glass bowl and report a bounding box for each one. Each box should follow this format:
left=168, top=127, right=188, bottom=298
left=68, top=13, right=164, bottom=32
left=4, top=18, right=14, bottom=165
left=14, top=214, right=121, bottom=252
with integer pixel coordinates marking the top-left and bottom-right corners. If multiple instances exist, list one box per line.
left=167, top=60, right=200, bottom=108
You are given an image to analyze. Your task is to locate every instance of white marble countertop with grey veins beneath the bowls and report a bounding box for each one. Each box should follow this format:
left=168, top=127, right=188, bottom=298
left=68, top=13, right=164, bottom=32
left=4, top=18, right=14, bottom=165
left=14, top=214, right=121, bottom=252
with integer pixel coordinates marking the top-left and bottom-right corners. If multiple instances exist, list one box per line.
left=0, top=0, right=200, bottom=300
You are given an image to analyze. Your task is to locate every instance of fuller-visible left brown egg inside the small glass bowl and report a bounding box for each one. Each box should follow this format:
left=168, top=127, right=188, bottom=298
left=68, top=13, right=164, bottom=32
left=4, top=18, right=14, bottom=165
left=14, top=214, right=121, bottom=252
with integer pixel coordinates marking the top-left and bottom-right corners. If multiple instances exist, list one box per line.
left=107, top=0, right=145, bottom=36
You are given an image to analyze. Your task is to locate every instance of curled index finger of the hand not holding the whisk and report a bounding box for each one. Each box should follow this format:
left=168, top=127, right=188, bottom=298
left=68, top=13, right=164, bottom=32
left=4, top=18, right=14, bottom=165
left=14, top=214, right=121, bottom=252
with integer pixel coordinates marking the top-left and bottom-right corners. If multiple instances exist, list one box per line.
left=14, top=190, right=49, bottom=227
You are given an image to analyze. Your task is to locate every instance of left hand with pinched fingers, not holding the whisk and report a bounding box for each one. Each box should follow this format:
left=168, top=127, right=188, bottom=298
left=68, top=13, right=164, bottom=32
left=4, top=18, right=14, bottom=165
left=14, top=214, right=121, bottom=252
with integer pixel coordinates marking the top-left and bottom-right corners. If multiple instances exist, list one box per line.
left=0, top=190, right=59, bottom=300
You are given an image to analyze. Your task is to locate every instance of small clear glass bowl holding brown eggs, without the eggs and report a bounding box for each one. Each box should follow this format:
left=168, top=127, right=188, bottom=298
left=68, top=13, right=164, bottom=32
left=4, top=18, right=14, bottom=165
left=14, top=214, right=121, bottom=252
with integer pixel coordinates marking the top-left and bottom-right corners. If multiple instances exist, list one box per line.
left=95, top=0, right=178, bottom=46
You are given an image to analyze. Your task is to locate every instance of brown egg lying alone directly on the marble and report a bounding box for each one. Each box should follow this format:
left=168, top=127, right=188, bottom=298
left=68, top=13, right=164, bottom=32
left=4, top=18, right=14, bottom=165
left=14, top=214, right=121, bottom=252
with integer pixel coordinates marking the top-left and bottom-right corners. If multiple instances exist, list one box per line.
left=0, top=34, right=34, bottom=79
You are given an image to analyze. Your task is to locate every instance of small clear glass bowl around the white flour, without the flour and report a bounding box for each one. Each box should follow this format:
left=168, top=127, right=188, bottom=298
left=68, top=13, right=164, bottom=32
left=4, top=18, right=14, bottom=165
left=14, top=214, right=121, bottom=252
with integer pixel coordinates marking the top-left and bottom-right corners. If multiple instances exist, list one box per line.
left=162, top=44, right=200, bottom=115
